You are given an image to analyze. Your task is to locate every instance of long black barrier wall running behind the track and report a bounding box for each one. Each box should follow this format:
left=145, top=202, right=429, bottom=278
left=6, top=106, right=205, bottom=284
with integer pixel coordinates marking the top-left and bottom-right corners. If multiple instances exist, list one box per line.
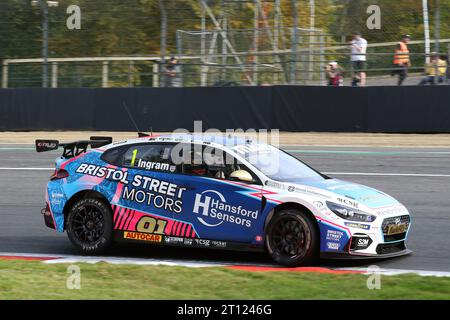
left=0, top=86, right=450, bottom=133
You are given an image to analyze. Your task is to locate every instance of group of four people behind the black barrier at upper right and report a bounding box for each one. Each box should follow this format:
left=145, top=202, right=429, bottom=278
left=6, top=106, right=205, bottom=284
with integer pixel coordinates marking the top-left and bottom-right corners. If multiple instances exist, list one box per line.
left=325, top=32, right=450, bottom=87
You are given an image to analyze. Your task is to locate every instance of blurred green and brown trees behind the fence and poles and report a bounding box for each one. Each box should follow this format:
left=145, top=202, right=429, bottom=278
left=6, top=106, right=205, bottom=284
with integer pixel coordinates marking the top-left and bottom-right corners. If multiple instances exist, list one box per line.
left=0, top=0, right=450, bottom=86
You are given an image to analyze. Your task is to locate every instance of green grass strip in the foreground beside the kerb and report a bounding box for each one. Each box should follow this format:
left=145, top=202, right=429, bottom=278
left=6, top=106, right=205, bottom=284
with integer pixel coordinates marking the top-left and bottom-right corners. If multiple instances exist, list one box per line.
left=0, top=260, right=450, bottom=300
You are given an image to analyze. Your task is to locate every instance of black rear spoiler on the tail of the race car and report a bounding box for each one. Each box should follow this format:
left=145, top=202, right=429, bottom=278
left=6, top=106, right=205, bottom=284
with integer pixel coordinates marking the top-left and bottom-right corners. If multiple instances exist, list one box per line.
left=36, top=137, right=112, bottom=158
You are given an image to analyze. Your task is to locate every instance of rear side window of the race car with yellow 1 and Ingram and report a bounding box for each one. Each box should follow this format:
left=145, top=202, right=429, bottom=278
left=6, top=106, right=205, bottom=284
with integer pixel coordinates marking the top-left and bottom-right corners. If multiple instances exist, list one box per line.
left=121, top=144, right=181, bottom=173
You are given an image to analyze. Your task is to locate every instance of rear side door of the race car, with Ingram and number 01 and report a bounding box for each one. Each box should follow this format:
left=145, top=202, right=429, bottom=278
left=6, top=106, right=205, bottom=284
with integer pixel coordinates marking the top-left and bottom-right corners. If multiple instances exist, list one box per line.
left=105, top=143, right=187, bottom=242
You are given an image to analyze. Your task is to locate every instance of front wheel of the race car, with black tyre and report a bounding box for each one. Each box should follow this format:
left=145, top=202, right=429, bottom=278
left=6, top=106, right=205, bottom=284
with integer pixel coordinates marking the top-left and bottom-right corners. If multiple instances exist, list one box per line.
left=266, top=209, right=320, bottom=267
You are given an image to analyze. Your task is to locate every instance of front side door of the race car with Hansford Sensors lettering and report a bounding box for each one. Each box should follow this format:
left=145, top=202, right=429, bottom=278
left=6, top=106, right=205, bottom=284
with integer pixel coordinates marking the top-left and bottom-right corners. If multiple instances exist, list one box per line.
left=171, top=145, right=264, bottom=243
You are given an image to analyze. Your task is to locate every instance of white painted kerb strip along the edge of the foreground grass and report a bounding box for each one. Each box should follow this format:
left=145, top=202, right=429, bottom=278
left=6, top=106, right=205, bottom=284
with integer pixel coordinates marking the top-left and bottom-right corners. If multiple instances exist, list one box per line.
left=0, top=252, right=450, bottom=277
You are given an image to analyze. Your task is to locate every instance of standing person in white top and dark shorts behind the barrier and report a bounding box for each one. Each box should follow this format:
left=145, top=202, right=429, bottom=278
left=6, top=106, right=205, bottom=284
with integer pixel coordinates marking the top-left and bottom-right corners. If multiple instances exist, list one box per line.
left=350, top=32, right=367, bottom=87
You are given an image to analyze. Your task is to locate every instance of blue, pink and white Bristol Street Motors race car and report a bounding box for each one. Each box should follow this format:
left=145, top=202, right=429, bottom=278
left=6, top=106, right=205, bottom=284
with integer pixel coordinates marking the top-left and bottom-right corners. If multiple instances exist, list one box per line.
left=36, top=134, right=411, bottom=267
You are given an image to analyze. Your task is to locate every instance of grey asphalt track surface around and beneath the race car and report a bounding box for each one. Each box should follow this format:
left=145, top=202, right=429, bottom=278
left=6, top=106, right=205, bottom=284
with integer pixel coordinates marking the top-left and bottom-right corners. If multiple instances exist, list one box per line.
left=0, top=145, right=450, bottom=271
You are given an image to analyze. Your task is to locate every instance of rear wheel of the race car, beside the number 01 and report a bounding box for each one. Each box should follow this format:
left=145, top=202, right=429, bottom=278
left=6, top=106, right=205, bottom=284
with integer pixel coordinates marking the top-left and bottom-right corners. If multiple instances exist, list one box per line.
left=66, top=198, right=113, bottom=254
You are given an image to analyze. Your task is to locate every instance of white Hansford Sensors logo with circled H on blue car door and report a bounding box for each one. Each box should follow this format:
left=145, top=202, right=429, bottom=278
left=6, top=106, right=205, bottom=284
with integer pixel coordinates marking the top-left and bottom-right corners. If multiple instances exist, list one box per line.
left=192, top=190, right=258, bottom=228
